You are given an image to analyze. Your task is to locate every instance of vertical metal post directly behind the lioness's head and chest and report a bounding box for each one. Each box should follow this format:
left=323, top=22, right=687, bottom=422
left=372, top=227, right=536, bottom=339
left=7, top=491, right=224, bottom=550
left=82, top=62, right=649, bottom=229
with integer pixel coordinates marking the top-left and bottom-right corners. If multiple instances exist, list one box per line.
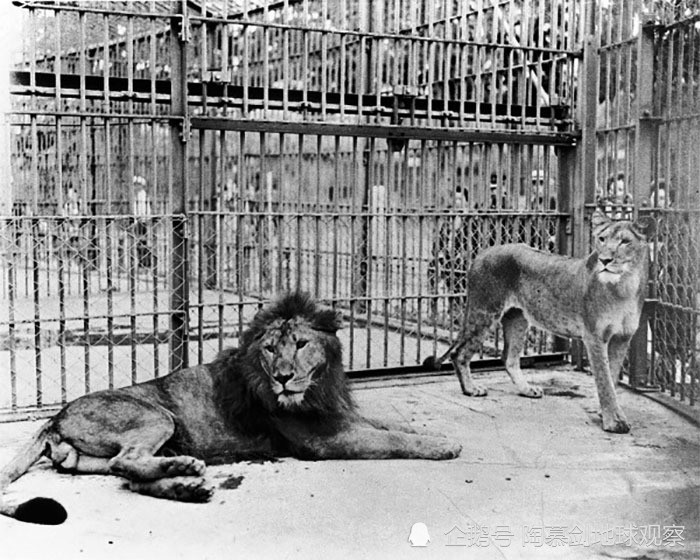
left=628, top=17, right=658, bottom=387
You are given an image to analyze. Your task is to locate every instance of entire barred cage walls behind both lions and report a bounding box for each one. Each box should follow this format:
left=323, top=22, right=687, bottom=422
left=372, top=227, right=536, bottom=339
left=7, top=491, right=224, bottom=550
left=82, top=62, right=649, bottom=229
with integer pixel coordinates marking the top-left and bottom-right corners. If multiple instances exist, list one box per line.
left=0, top=0, right=700, bottom=416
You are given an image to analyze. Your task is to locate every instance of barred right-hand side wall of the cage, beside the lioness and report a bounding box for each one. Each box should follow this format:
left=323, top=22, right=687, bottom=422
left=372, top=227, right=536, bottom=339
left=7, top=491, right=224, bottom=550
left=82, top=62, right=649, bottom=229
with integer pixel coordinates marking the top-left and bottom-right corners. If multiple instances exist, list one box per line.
left=595, top=1, right=700, bottom=405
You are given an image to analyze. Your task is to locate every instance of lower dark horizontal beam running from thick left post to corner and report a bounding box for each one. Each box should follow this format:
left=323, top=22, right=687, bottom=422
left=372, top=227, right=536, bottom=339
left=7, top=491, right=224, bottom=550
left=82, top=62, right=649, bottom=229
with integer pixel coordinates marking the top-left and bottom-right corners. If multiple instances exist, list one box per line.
left=191, top=117, right=576, bottom=146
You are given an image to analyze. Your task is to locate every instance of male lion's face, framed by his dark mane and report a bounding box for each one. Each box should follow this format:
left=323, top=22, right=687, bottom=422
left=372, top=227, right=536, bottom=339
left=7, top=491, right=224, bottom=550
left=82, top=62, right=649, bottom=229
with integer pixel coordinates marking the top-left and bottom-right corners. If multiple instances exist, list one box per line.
left=260, top=318, right=326, bottom=408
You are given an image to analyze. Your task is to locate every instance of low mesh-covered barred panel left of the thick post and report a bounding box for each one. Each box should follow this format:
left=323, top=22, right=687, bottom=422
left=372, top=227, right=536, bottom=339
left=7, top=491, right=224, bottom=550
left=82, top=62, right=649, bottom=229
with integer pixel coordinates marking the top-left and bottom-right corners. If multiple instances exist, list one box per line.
left=0, top=216, right=178, bottom=408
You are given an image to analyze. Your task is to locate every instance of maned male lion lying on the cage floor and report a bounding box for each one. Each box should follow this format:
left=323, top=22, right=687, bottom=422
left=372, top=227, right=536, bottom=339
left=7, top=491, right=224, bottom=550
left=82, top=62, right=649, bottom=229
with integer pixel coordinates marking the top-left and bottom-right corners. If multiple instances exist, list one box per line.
left=0, top=294, right=461, bottom=524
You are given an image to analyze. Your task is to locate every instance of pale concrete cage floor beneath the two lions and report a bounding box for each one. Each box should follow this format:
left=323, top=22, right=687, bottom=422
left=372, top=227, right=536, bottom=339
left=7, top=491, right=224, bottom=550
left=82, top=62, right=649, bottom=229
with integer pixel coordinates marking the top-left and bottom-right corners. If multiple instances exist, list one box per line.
left=0, top=369, right=700, bottom=560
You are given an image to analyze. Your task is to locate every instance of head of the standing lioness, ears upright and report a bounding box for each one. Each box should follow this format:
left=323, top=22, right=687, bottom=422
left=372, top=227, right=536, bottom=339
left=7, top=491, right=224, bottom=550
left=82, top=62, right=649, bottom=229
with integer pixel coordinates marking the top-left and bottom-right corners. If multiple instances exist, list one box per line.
left=592, top=209, right=653, bottom=282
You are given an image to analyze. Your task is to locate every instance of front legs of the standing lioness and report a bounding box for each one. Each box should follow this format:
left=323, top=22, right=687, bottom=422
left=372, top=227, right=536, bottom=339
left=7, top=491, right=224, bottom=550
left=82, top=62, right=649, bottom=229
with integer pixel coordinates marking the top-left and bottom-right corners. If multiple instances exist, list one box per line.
left=584, top=335, right=630, bottom=434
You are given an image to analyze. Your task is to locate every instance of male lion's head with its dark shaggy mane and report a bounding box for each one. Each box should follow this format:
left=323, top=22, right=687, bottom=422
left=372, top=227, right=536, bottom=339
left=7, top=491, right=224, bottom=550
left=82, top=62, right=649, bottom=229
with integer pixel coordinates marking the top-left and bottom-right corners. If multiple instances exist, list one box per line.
left=242, top=293, right=351, bottom=412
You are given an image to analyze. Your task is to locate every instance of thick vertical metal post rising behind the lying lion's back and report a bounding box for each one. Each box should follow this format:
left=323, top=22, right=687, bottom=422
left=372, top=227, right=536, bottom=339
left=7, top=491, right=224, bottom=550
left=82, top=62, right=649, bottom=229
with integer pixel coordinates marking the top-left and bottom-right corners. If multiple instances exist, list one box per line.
left=170, top=0, right=190, bottom=371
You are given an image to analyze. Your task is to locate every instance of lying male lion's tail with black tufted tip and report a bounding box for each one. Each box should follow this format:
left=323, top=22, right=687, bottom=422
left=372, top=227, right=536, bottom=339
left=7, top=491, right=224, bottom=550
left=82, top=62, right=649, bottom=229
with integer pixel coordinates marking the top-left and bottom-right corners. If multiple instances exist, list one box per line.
left=0, top=421, right=68, bottom=525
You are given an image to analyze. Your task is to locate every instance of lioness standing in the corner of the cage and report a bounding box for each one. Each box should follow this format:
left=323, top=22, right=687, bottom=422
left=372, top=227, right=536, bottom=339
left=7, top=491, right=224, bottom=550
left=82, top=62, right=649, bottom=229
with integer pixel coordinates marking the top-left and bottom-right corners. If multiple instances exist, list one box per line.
left=427, top=210, right=652, bottom=433
